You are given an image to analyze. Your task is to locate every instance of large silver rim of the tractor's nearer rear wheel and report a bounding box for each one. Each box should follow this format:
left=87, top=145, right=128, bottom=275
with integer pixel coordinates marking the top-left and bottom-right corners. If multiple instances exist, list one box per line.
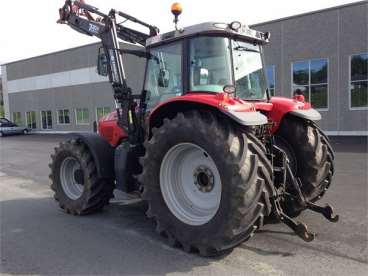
left=160, top=143, right=222, bottom=225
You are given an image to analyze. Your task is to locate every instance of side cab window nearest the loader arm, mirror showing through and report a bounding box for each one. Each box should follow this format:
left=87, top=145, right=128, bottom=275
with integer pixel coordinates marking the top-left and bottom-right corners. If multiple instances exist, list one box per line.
left=144, top=42, right=183, bottom=109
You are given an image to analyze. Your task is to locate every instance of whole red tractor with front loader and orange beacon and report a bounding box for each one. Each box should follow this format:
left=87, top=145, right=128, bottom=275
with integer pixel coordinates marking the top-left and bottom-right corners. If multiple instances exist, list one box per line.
left=50, top=1, right=338, bottom=256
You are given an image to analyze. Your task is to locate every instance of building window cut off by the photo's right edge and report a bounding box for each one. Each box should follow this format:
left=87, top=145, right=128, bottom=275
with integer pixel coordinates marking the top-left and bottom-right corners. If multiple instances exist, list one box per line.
left=350, top=53, right=368, bottom=109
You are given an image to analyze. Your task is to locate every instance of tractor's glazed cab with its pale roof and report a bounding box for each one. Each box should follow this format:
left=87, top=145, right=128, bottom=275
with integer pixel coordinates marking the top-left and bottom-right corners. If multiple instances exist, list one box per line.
left=144, top=22, right=269, bottom=107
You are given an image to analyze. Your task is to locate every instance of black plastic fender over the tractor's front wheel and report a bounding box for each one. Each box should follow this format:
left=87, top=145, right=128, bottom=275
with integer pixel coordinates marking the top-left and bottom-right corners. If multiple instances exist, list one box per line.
left=72, top=133, right=115, bottom=179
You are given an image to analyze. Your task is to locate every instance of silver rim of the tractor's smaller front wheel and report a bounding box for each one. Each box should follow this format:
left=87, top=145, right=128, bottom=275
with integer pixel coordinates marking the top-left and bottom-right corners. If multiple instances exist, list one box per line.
left=60, top=157, right=83, bottom=200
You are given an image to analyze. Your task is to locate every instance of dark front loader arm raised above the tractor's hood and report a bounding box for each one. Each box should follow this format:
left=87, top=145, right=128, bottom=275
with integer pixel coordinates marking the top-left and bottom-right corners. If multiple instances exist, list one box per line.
left=58, top=0, right=159, bottom=140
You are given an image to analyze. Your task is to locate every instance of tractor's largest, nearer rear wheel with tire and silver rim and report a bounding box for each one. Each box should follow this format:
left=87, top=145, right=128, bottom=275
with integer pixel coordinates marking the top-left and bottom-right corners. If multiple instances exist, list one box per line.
left=139, top=112, right=272, bottom=256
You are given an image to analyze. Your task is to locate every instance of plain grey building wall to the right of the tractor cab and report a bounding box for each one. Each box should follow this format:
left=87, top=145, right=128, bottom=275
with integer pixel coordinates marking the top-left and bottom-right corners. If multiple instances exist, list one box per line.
left=254, top=1, right=368, bottom=133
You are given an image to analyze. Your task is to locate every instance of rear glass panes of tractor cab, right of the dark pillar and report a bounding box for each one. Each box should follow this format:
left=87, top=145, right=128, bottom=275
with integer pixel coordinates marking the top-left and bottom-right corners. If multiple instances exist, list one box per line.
left=190, top=37, right=267, bottom=100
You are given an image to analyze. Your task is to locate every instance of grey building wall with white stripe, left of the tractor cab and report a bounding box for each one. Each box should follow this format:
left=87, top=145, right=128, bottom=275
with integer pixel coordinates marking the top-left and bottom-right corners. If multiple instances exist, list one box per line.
left=4, top=44, right=146, bottom=131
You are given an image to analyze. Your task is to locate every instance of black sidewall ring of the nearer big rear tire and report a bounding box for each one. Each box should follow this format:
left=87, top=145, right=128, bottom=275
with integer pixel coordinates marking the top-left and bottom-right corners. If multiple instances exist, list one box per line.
left=146, top=119, right=244, bottom=244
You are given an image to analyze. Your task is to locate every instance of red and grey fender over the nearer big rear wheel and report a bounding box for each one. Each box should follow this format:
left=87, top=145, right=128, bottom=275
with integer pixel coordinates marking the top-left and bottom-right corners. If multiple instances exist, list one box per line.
left=149, top=93, right=267, bottom=135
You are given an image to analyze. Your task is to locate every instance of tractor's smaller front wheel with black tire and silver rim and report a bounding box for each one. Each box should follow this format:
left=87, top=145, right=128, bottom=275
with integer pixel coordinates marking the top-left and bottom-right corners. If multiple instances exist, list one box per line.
left=49, top=140, right=114, bottom=215
